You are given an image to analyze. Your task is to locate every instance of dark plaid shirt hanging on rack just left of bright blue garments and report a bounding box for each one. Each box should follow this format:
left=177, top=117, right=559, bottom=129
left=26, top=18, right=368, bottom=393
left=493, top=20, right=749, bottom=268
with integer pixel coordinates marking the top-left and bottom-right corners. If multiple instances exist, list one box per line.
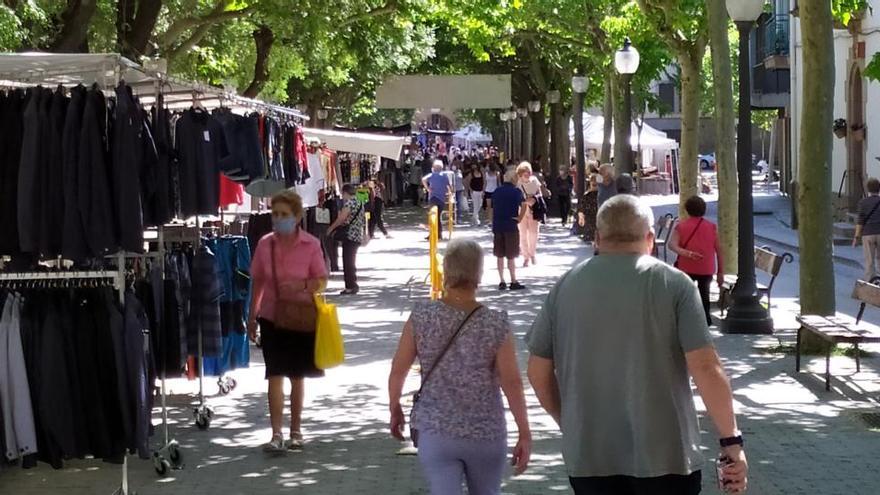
left=187, top=247, right=223, bottom=357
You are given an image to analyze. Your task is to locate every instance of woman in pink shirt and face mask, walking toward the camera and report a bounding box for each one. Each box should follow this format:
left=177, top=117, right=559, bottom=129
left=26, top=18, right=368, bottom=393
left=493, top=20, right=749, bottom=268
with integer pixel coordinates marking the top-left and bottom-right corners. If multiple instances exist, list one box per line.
left=248, top=190, right=327, bottom=453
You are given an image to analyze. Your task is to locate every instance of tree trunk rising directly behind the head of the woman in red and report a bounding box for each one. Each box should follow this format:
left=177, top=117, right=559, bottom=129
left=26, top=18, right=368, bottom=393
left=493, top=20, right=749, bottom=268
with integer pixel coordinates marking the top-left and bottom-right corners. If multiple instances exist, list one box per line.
left=678, top=50, right=703, bottom=218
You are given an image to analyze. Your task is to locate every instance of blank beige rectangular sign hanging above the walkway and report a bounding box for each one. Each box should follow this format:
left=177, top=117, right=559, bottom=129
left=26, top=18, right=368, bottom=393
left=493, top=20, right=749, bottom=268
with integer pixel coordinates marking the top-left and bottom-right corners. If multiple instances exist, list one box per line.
left=376, top=74, right=512, bottom=110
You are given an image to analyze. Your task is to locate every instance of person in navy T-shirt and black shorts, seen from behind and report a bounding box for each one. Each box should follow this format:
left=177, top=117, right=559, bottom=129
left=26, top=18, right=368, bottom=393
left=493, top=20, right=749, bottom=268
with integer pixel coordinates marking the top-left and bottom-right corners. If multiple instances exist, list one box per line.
left=492, top=167, right=529, bottom=290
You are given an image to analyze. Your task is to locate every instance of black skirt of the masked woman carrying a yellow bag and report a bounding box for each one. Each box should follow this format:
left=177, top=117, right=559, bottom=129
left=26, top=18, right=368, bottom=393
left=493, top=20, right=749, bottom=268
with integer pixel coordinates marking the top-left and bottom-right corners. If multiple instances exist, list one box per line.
left=259, top=318, right=324, bottom=378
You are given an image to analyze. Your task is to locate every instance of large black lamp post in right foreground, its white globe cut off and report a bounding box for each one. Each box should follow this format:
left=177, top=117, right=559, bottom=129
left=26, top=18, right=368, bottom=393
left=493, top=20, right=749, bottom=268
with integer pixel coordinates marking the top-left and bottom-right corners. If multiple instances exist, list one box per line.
left=721, top=0, right=773, bottom=334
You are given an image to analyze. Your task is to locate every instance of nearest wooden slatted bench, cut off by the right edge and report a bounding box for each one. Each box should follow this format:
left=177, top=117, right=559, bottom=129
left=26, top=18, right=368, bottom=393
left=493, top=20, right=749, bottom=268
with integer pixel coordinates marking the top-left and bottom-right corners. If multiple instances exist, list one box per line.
left=795, top=280, right=880, bottom=390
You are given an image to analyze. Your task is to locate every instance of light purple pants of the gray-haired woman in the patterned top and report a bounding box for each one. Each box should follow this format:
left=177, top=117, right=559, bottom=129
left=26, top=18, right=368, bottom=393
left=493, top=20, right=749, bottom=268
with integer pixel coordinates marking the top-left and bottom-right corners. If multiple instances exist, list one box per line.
left=419, top=431, right=507, bottom=495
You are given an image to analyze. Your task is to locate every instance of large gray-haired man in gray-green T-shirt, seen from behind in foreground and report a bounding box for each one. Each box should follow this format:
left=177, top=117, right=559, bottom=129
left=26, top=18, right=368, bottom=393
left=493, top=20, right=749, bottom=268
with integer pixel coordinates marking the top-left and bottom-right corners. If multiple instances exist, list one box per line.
left=526, top=195, right=748, bottom=495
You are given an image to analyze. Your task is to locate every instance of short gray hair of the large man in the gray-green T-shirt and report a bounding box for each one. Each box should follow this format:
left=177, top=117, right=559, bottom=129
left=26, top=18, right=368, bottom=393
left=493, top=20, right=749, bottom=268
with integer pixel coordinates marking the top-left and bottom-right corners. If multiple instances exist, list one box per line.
left=596, top=194, right=654, bottom=243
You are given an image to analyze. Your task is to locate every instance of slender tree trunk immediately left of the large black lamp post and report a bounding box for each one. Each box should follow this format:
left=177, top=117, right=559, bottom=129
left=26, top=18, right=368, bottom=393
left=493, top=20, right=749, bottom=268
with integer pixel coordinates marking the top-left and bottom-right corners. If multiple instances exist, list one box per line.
left=706, top=0, right=739, bottom=273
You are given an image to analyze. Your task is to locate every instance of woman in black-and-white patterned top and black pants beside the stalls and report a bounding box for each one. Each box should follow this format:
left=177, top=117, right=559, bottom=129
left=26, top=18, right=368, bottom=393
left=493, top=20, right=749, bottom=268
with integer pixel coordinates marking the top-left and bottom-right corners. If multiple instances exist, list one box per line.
left=327, top=184, right=367, bottom=295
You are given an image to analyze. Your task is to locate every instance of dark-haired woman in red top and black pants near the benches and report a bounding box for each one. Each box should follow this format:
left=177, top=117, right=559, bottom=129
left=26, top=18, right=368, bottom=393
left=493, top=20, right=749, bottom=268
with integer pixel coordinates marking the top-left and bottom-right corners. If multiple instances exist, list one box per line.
left=669, top=196, right=724, bottom=326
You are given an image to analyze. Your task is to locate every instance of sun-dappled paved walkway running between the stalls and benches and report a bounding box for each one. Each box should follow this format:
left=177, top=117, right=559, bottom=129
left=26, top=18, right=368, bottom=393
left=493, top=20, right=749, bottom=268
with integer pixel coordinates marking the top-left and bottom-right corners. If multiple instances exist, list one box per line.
left=0, top=203, right=880, bottom=495
